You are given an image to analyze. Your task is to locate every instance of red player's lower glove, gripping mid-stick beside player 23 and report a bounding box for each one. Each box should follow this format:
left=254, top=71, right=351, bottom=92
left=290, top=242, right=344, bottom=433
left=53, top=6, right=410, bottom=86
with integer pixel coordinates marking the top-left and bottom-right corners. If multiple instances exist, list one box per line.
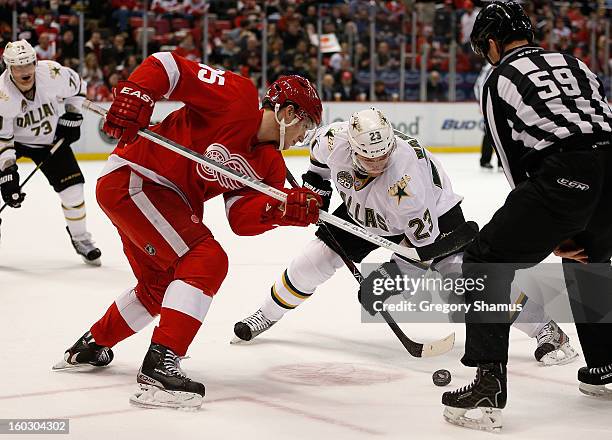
left=261, top=188, right=323, bottom=226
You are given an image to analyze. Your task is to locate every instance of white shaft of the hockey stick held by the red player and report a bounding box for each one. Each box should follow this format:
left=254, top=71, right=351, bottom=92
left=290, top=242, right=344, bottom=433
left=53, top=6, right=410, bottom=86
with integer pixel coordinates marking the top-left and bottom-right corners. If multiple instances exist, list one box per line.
left=83, top=100, right=432, bottom=262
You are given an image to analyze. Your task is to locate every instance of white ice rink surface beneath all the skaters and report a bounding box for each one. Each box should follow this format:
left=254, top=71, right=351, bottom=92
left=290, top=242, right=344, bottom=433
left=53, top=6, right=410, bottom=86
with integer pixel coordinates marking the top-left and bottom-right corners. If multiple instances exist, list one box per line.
left=0, top=154, right=612, bottom=440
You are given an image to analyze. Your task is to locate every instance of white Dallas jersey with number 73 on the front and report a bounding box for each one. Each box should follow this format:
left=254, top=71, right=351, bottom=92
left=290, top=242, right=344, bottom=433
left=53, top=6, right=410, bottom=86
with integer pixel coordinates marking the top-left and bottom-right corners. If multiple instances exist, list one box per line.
left=0, top=60, right=86, bottom=168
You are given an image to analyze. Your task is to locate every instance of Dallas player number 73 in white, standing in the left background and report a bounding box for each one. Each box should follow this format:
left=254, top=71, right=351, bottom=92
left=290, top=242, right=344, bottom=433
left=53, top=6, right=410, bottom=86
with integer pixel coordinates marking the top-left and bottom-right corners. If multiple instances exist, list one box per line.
left=0, top=40, right=101, bottom=266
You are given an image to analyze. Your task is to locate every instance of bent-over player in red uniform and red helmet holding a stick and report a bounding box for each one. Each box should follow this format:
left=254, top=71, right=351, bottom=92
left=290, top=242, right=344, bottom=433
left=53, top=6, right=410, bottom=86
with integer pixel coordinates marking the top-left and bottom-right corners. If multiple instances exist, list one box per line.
left=54, top=52, right=322, bottom=407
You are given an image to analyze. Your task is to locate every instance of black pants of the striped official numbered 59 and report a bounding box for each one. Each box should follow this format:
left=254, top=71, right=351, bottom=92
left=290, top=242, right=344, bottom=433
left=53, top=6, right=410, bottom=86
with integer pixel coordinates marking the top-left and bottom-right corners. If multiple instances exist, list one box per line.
left=462, top=150, right=612, bottom=367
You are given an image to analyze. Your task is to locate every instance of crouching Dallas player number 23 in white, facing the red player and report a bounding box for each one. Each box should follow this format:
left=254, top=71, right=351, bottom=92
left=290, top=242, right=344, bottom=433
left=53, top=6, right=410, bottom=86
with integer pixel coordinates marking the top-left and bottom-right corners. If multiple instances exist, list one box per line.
left=234, top=108, right=577, bottom=365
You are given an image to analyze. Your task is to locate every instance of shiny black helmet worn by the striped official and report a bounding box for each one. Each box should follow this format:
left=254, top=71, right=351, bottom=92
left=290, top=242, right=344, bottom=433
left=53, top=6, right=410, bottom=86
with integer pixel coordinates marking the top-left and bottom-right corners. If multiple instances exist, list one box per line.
left=470, top=1, right=533, bottom=64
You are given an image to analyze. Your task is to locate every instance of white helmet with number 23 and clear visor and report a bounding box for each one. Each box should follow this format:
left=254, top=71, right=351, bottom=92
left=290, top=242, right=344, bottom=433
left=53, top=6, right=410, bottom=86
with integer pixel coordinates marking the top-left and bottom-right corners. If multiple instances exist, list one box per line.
left=348, top=107, right=395, bottom=174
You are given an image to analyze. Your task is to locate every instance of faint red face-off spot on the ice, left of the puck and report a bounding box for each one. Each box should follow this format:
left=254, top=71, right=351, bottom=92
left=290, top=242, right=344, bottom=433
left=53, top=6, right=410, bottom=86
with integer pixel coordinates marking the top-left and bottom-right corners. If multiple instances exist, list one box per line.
left=264, top=362, right=405, bottom=386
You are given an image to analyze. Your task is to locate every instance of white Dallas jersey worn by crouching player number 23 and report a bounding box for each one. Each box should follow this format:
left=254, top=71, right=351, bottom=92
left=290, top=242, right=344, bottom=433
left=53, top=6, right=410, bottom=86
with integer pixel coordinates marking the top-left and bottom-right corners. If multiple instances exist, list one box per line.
left=310, top=122, right=463, bottom=247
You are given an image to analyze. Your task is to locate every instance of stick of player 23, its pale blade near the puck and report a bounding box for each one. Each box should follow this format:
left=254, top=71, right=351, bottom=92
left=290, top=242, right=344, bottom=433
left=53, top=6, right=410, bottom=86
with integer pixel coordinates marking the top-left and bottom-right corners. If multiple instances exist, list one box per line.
left=285, top=167, right=455, bottom=357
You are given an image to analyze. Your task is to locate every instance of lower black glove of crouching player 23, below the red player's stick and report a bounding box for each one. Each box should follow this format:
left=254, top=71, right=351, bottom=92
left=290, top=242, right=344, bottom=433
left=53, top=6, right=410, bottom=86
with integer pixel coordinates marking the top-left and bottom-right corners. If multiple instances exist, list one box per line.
left=357, top=261, right=402, bottom=316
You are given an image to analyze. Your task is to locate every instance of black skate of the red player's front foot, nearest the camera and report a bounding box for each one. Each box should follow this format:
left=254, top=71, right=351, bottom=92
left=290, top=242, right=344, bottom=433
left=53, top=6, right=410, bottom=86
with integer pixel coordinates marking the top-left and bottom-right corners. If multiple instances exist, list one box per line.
left=130, top=343, right=205, bottom=409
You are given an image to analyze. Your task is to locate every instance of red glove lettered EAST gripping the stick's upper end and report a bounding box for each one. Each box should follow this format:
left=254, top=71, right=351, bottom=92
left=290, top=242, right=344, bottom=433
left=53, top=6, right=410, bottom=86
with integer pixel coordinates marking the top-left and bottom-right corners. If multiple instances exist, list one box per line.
left=102, top=81, right=155, bottom=143
